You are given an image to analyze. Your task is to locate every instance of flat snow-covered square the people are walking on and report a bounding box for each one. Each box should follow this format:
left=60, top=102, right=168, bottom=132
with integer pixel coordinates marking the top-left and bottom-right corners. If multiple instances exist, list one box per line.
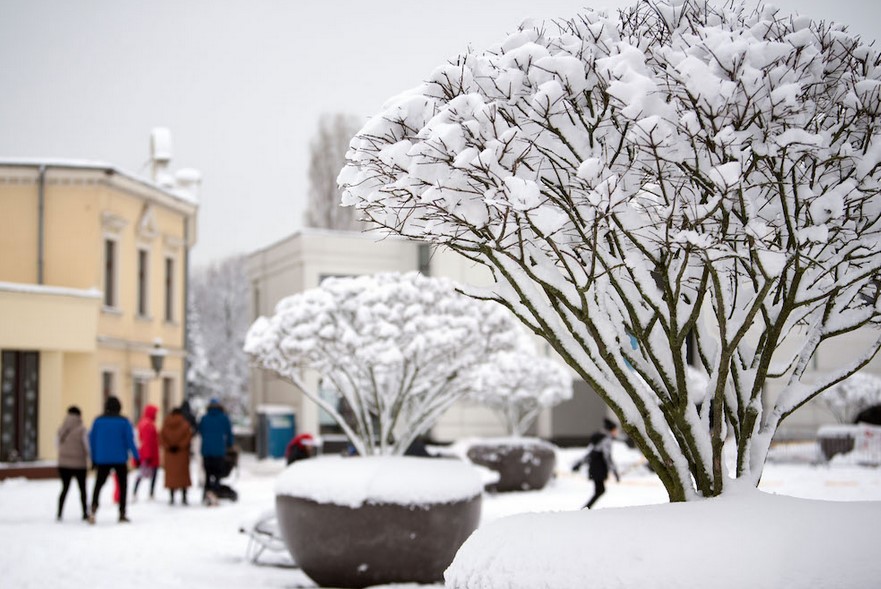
left=0, top=445, right=881, bottom=589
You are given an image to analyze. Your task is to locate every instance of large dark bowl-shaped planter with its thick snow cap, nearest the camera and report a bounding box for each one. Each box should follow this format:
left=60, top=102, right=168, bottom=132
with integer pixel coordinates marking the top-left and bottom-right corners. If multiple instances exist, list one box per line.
left=276, top=457, right=481, bottom=587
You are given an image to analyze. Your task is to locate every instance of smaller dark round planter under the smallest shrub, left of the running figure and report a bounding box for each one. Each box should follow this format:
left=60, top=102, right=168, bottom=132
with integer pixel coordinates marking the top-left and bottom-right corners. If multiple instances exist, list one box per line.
left=467, top=438, right=557, bottom=492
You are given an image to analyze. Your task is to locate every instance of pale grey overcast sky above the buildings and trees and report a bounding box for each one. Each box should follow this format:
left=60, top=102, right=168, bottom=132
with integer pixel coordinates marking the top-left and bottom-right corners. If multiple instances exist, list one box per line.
left=0, top=0, right=881, bottom=265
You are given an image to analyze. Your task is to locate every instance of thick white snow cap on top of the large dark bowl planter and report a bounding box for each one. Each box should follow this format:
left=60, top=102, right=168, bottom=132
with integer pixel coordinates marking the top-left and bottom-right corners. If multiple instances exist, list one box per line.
left=275, top=456, right=483, bottom=507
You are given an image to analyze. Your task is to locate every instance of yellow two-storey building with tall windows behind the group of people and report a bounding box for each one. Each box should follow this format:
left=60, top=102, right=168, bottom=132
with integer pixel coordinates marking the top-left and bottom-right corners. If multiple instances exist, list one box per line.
left=0, top=160, right=198, bottom=468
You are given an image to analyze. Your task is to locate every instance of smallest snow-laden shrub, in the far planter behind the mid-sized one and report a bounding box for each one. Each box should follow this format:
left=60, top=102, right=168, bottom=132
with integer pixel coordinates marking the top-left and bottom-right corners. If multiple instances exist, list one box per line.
left=467, top=338, right=572, bottom=436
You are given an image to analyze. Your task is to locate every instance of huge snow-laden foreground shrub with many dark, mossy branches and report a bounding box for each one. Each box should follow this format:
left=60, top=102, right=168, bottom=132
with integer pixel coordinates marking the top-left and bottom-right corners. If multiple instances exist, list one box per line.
left=339, top=0, right=881, bottom=501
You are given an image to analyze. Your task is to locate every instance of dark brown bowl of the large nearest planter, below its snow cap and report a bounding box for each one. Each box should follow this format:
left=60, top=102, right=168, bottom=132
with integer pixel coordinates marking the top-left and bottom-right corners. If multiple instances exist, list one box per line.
left=276, top=458, right=481, bottom=587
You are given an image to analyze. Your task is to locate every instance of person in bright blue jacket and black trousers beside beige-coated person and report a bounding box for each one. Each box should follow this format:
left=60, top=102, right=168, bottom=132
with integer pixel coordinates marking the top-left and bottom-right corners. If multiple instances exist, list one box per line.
left=89, top=396, right=140, bottom=524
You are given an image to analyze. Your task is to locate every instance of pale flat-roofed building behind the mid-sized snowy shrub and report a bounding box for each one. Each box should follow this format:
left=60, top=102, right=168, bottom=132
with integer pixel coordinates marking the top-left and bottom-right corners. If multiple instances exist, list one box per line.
left=246, top=229, right=607, bottom=442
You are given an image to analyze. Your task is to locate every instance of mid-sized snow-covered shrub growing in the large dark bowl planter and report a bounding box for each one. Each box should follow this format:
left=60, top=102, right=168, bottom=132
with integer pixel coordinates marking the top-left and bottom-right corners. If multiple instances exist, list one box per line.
left=245, top=272, right=522, bottom=455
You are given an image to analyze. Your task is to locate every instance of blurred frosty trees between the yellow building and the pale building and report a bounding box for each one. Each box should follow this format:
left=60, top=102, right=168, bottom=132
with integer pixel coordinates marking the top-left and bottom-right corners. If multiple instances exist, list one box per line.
left=190, top=256, right=251, bottom=418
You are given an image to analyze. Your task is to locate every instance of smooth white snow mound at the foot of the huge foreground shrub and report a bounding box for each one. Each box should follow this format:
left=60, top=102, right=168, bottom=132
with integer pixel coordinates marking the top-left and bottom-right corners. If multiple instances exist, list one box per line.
left=445, top=482, right=881, bottom=589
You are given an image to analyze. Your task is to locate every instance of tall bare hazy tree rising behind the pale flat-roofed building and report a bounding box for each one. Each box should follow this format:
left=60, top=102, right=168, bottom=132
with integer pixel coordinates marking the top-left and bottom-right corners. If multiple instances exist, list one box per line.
left=304, top=113, right=363, bottom=230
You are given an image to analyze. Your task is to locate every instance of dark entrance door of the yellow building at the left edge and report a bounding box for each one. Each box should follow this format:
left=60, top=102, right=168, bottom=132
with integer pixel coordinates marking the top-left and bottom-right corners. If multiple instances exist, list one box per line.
left=0, top=350, right=40, bottom=462
